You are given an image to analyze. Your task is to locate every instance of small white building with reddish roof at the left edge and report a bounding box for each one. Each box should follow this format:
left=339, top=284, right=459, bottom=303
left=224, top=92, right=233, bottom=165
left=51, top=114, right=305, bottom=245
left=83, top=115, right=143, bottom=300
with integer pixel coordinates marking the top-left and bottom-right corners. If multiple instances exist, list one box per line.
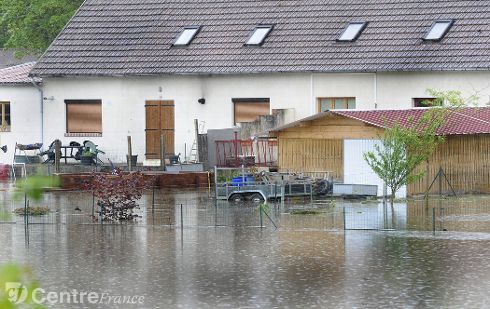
left=0, top=62, right=43, bottom=163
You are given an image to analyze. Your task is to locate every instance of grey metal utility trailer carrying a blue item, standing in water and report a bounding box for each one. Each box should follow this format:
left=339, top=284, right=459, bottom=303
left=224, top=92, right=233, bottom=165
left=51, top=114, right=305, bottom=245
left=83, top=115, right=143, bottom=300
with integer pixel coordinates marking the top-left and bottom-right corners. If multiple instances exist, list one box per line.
left=214, top=167, right=312, bottom=203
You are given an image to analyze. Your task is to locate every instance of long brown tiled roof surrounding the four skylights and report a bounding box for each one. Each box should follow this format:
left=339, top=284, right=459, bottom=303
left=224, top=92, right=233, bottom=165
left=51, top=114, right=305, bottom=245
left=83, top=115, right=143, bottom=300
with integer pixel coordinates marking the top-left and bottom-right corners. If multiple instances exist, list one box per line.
left=32, top=0, right=490, bottom=76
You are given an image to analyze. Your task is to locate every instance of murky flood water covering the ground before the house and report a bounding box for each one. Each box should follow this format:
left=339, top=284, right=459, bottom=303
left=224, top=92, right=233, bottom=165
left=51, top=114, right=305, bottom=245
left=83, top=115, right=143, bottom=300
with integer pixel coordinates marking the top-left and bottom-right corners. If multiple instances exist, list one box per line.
left=0, top=191, right=490, bottom=308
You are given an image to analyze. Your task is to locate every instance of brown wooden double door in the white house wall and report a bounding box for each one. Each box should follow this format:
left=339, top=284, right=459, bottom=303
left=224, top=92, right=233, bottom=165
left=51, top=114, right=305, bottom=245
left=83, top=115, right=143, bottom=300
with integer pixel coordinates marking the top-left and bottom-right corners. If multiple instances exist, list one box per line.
left=145, top=101, right=175, bottom=159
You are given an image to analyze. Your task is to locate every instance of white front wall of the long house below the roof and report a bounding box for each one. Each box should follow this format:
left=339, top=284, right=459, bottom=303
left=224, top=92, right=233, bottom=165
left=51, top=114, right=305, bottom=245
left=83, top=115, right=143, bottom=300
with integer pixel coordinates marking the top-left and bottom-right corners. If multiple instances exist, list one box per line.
left=40, top=72, right=490, bottom=162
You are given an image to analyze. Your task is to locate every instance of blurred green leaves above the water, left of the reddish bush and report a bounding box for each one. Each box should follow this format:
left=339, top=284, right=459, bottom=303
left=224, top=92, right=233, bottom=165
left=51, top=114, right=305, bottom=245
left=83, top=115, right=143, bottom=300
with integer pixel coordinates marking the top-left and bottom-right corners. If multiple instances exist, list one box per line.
left=14, top=175, right=60, bottom=201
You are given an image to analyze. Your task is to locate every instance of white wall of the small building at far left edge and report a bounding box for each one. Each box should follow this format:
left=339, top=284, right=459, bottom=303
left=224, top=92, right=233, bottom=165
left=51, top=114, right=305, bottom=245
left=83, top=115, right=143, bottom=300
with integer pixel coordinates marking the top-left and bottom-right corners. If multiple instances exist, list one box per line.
left=0, top=85, right=41, bottom=164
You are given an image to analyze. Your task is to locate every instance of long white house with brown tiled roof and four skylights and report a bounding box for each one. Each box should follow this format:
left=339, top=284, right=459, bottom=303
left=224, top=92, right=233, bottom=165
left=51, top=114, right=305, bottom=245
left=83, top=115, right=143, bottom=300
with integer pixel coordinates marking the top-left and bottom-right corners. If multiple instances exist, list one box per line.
left=31, top=0, right=490, bottom=161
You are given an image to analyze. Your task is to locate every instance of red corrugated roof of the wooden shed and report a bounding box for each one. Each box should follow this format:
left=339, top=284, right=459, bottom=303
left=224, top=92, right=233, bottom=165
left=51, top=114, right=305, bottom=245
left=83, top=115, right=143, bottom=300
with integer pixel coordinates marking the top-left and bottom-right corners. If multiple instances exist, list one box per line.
left=271, top=107, right=490, bottom=135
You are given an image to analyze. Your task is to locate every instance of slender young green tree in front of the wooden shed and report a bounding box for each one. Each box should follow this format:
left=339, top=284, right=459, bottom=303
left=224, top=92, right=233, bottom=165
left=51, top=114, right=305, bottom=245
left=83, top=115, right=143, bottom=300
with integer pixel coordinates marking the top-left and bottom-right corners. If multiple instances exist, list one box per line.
left=363, top=90, right=477, bottom=204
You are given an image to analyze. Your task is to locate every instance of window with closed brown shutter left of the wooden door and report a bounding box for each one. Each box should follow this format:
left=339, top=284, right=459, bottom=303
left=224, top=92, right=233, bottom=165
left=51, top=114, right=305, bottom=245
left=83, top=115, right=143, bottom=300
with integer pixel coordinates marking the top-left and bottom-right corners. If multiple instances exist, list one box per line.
left=65, top=100, right=102, bottom=134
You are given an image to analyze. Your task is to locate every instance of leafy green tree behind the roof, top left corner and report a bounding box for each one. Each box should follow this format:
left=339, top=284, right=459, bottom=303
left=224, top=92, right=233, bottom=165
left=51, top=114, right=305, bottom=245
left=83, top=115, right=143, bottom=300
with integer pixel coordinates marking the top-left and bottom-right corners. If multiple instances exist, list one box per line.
left=0, top=0, right=83, bottom=56
